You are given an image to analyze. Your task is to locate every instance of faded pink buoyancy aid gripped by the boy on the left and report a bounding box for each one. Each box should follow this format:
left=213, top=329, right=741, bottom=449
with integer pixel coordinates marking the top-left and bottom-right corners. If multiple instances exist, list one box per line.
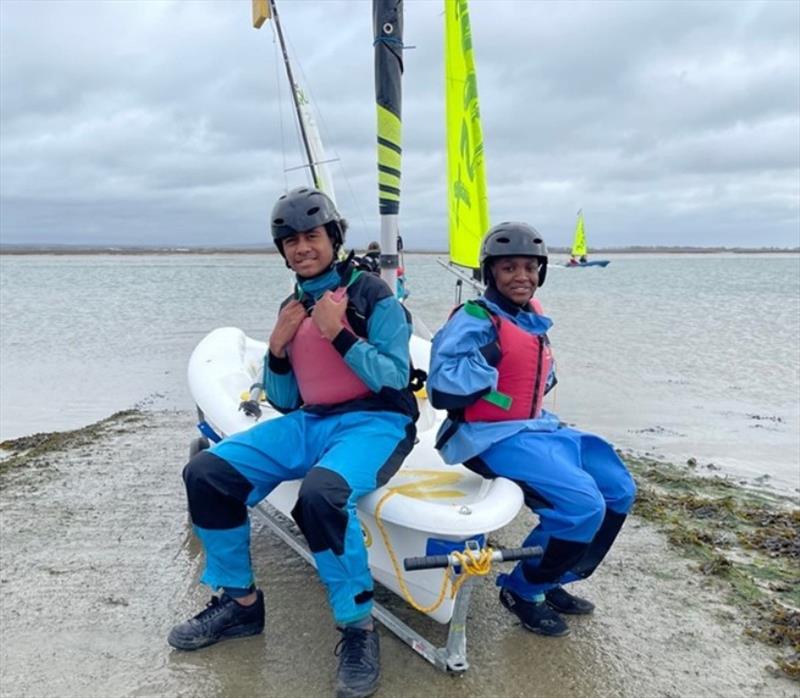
left=286, top=288, right=372, bottom=405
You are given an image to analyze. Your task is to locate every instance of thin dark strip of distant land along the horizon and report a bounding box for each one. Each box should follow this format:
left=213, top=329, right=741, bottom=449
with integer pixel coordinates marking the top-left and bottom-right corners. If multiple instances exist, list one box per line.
left=0, top=244, right=800, bottom=259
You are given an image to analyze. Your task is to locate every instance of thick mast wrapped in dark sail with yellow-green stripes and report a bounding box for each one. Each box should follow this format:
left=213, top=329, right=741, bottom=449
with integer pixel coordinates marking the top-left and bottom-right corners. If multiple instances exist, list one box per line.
left=372, top=0, right=403, bottom=289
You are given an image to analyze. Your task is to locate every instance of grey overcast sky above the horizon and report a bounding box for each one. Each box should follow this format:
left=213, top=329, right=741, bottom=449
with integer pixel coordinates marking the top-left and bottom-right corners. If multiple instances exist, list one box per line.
left=0, top=0, right=800, bottom=249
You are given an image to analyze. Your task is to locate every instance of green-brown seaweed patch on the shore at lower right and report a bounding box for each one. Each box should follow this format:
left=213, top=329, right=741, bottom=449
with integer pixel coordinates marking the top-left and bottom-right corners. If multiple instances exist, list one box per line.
left=624, top=454, right=800, bottom=680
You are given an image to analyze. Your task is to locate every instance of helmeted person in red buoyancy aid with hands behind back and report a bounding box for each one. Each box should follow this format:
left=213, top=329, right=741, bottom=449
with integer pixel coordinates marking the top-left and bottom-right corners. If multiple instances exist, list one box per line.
left=428, top=222, right=636, bottom=636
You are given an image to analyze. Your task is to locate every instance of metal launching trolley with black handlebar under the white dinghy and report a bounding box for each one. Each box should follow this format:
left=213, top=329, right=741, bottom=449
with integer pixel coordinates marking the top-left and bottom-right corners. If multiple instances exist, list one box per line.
left=250, top=500, right=542, bottom=674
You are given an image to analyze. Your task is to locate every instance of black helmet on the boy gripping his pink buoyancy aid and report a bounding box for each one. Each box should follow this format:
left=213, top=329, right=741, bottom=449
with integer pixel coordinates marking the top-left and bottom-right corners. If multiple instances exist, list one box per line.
left=270, top=187, right=347, bottom=258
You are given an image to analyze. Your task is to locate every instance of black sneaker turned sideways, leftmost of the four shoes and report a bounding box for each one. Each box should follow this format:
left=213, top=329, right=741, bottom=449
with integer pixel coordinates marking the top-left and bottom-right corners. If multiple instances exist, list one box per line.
left=167, top=589, right=264, bottom=650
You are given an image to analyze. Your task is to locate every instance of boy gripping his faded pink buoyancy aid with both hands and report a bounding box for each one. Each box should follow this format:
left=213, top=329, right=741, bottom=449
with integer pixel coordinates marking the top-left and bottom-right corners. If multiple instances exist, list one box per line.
left=168, top=187, right=418, bottom=697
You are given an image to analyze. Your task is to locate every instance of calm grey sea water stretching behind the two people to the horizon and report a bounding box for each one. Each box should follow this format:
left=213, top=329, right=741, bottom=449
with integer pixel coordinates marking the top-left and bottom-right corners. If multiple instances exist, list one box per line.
left=0, top=254, right=800, bottom=490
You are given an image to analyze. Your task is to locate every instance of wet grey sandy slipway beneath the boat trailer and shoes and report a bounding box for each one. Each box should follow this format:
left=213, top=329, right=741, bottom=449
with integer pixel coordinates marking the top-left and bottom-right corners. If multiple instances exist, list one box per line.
left=0, top=412, right=797, bottom=698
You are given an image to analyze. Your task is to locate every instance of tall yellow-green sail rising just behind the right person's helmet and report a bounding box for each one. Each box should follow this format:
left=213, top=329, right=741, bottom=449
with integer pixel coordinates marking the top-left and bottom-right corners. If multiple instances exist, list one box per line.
left=444, top=0, right=489, bottom=269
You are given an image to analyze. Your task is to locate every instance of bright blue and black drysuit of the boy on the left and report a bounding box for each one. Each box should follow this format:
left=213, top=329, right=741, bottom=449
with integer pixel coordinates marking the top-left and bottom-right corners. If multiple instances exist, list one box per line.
left=184, top=264, right=416, bottom=625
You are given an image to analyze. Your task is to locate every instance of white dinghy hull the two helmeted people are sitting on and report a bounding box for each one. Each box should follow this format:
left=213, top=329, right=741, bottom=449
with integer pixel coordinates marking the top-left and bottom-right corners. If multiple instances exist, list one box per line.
left=188, top=327, right=523, bottom=623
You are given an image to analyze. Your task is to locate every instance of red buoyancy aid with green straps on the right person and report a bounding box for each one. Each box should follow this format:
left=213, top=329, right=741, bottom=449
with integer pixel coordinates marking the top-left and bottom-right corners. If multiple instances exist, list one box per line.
left=464, top=302, right=553, bottom=422
